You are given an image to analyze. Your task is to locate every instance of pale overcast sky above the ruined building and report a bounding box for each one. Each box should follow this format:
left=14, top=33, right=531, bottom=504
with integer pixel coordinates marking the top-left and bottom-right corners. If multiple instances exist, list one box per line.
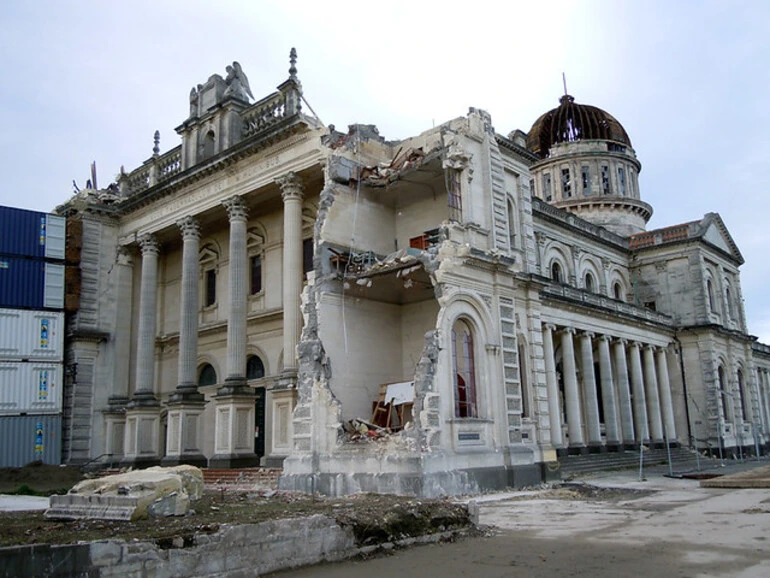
left=0, top=0, right=770, bottom=343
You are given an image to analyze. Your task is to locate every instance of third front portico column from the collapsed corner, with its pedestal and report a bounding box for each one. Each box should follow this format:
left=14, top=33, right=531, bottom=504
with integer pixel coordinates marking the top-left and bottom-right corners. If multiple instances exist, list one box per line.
left=163, top=217, right=206, bottom=467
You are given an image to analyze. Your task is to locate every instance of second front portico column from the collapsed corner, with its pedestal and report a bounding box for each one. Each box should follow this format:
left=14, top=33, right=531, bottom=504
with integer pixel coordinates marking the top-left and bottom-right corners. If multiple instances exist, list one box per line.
left=209, top=195, right=259, bottom=468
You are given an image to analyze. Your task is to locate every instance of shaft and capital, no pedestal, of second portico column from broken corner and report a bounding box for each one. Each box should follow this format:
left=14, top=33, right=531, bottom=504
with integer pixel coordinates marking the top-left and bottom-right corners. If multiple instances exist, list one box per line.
left=222, top=196, right=248, bottom=388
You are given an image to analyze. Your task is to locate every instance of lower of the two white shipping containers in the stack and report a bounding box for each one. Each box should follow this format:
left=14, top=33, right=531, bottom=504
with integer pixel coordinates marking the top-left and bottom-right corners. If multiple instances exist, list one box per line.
left=0, top=361, right=64, bottom=415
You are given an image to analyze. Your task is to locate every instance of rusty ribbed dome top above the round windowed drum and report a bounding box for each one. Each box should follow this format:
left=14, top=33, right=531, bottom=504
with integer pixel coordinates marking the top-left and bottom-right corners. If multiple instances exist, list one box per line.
left=527, top=94, right=631, bottom=159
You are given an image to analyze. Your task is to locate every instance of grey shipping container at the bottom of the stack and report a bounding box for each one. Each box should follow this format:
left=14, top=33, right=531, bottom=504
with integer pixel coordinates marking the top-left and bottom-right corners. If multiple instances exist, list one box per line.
left=0, top=415, right=62, bottom=468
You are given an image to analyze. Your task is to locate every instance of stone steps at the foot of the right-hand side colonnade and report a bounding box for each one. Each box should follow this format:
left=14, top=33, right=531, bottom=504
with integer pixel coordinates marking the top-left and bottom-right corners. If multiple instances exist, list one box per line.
left=558, top=446, right=710, bottom=480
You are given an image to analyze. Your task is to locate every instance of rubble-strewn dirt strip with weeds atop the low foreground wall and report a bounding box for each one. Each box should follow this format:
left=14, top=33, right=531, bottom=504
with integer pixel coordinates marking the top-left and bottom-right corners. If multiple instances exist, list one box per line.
left=0, top=480, right=470, bottom=548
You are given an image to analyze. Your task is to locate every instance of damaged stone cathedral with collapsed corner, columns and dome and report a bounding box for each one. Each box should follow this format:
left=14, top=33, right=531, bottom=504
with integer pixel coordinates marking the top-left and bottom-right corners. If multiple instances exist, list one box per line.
left=58, top=50, right=770, bottom=496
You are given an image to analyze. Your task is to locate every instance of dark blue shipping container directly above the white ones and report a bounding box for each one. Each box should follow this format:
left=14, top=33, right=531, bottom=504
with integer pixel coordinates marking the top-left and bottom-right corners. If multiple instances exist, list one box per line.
left=0, top=257, right=64, bottom=309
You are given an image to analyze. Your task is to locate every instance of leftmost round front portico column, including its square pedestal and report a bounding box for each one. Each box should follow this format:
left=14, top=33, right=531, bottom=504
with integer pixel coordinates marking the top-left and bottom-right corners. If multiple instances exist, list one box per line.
left=121, top=234, right=160, bottom=467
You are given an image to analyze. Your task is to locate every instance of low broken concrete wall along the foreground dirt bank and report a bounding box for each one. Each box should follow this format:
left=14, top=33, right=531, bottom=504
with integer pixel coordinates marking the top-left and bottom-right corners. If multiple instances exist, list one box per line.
left=0, top=515, right=472, bottom=578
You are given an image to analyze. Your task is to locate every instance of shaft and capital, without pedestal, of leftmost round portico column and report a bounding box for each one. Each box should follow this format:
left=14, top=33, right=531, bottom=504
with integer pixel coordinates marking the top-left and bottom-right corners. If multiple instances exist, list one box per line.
left=132, top=235, right=160, bottom=403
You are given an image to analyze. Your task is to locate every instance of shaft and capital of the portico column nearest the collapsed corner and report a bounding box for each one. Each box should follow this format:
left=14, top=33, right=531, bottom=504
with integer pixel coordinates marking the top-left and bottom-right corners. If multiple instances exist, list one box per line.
left=276, top=172, right=304, bottom=373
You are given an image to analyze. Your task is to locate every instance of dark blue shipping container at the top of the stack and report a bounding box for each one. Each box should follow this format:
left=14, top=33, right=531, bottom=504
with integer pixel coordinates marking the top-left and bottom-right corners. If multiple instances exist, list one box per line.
left=0, top=207, right=66, bottom=261
